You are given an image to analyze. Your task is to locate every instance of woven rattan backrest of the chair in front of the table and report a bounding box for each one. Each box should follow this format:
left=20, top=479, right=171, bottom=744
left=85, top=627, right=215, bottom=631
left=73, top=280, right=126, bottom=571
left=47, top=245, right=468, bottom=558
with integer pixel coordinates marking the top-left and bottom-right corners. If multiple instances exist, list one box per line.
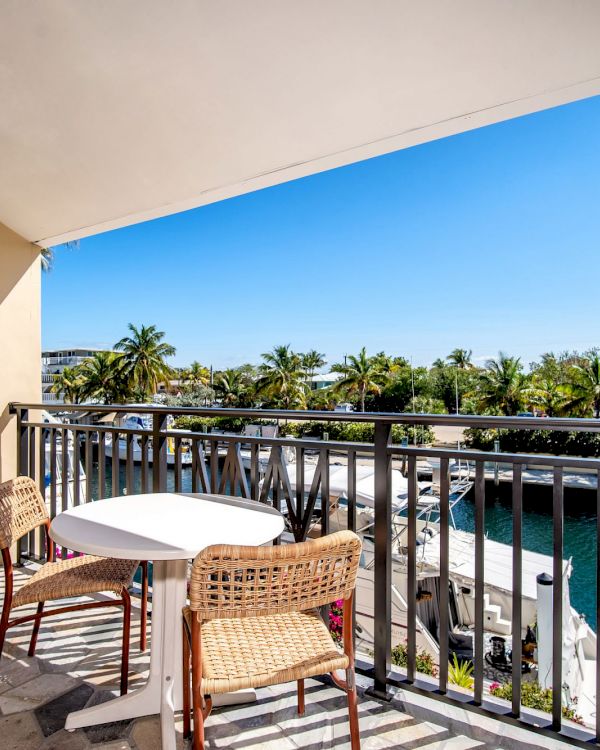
left=190, top=531, right=361, bottom=620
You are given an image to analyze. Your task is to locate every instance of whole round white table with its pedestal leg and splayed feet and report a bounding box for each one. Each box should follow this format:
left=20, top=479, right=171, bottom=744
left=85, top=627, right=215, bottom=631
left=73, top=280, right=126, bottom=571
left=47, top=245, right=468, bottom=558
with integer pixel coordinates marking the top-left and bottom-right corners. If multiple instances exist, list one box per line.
left=50, top=492, right=284, bottom=750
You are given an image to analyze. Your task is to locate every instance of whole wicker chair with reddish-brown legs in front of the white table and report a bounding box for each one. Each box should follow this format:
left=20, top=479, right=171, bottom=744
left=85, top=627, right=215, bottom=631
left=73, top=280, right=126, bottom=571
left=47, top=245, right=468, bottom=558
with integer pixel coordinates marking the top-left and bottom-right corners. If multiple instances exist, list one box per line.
left=183, top=531, right=361, bottom=750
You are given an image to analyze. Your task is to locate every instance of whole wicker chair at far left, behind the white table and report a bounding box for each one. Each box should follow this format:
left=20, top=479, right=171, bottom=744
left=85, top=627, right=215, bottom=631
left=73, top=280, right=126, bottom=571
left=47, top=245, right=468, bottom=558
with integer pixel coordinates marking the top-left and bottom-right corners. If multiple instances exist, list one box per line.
left=0, top=477, right=147, bottom=695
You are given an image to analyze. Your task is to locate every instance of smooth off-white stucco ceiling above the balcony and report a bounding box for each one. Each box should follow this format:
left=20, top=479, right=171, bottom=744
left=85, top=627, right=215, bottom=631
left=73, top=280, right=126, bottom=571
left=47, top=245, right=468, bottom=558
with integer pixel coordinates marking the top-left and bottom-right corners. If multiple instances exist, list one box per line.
left=0, top=0, right=600, bottom=245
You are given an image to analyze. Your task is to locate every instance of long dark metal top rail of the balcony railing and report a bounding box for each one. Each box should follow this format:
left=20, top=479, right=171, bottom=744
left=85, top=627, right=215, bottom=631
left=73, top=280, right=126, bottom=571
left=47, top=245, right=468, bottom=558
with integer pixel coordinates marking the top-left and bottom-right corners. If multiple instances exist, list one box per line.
left=11, top=402, right=600, bottom=432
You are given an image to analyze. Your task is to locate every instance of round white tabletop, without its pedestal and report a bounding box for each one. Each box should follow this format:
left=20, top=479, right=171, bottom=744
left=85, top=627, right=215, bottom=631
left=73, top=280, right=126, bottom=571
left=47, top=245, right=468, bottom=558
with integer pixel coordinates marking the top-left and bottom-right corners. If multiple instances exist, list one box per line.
left=50, top=492, right=283, bottom=560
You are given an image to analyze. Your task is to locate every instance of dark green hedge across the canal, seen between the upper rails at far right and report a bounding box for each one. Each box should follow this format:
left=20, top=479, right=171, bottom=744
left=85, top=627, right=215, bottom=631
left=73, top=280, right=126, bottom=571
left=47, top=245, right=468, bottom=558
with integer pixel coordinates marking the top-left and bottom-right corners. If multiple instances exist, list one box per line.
left=465, top=428, right=600, bottom=458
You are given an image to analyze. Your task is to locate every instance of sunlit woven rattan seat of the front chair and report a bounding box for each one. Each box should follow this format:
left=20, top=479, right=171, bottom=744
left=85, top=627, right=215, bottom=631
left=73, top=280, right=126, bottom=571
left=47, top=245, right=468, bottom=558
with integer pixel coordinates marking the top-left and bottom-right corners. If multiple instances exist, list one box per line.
left=183, top=607, right=349, bottom=695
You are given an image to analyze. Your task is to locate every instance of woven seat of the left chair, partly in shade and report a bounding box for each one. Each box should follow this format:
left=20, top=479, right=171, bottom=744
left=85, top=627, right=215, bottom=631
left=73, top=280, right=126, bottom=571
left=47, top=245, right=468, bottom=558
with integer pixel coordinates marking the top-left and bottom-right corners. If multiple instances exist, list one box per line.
left=12, top=555, right=139, bottom=607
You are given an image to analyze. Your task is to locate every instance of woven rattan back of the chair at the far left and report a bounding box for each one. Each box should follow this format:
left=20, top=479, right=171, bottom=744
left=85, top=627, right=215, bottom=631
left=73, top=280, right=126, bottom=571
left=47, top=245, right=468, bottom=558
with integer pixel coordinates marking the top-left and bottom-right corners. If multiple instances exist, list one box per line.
left=0, top=477, right=48, bottom=549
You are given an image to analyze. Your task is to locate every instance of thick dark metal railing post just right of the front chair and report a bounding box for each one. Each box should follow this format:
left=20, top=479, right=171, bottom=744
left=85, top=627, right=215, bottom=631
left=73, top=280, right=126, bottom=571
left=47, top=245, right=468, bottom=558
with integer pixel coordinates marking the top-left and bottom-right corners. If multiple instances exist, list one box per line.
left=370, top=422, right=392, bottom=700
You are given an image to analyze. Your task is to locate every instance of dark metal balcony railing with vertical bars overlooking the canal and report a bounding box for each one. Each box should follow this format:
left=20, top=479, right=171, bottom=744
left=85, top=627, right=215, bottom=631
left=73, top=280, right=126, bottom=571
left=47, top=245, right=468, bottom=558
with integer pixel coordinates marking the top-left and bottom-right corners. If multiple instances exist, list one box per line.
left=12, top=403, right=600, bottom=745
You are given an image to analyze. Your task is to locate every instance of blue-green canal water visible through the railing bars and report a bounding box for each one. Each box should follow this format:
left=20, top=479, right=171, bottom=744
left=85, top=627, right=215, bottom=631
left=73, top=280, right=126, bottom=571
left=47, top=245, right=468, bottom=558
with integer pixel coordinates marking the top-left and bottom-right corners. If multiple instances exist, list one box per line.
left=92, top=461, right=596, bottom=630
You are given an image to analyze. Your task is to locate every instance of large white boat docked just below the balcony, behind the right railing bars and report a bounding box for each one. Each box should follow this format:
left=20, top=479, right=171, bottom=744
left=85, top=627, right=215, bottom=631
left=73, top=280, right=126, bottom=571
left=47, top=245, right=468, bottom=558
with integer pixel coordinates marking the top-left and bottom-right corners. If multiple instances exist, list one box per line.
left=329, top=499, right=596, bottom=726
